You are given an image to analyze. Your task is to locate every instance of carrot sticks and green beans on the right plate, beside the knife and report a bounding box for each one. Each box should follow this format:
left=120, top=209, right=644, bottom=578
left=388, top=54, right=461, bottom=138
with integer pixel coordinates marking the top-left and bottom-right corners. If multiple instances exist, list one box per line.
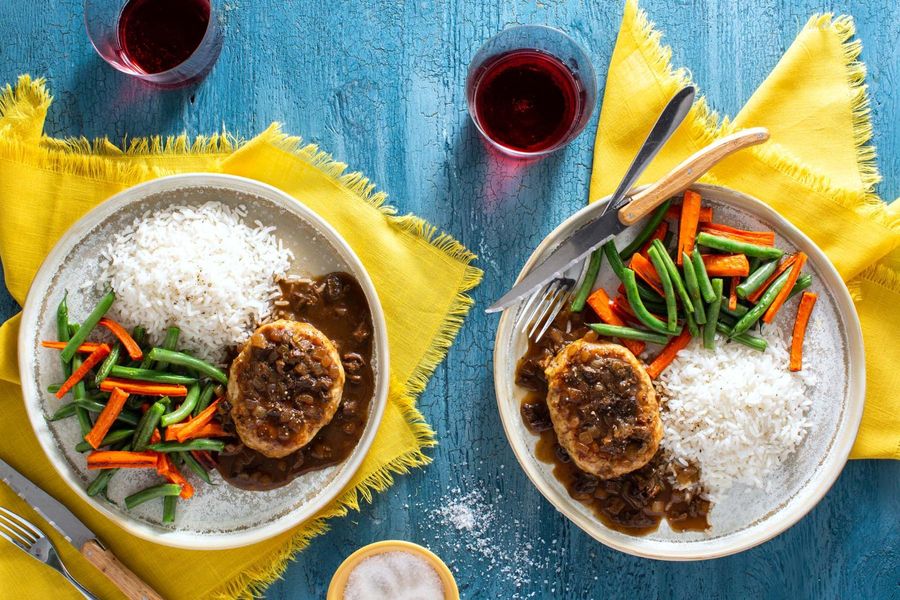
left=572, top=190, right=816, bottom=378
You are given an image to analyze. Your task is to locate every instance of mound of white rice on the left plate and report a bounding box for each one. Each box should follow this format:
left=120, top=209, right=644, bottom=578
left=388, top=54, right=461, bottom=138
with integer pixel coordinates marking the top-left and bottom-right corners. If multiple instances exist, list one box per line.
left=97, top=202, right=293, bottom=362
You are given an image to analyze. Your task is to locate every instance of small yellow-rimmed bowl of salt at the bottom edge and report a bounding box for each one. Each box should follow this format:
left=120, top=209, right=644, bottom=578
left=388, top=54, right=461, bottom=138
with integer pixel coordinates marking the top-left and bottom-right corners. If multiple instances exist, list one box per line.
left=327, top=540, right=459, bottom=600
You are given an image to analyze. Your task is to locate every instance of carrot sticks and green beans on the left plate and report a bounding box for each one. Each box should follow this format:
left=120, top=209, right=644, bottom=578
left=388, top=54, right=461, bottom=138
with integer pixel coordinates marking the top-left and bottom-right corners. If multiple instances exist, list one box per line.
left=42, top=292, right=229, bottom=523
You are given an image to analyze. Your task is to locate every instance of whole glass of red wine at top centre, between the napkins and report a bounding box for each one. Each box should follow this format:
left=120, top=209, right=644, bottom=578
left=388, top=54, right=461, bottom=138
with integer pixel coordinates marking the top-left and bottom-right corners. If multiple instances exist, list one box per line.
left=466, top=25, right=597, bottom=158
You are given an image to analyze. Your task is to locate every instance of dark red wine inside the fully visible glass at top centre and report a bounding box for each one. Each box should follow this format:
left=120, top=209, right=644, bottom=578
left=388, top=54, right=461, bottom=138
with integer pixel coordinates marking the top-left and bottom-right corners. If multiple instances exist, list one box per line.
left=473, top=50, right=584, bottom=152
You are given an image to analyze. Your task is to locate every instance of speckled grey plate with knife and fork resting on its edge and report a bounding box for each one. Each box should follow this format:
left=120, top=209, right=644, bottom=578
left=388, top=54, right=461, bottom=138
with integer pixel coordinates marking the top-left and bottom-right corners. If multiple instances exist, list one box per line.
left=494, top=185, right=865, bottom=560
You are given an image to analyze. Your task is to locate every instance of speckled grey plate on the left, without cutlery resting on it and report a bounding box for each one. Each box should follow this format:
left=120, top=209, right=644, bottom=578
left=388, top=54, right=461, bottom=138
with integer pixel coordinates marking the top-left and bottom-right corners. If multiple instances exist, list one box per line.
left=19, top=174, right=388, bottom=549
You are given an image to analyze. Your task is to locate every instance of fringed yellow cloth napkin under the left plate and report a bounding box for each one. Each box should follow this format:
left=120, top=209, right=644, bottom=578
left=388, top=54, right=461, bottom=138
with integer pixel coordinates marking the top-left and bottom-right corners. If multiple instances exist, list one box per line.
left=0, top=77, right=481, bottom=599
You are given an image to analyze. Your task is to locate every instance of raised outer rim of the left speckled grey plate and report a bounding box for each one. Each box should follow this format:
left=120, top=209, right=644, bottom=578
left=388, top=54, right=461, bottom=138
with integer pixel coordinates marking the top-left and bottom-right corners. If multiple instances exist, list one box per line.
left=18, top=173, right=390, bottom=550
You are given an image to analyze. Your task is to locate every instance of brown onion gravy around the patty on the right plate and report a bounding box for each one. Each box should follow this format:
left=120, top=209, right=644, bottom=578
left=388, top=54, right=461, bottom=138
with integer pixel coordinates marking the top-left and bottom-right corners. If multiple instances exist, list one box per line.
left=516, top=312, right=710, bottom=535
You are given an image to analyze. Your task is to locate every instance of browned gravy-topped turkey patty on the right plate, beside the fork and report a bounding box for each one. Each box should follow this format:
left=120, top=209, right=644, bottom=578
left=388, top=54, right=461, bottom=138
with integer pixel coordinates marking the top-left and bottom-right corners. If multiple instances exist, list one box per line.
left=545, top=340, right=662, bottom=479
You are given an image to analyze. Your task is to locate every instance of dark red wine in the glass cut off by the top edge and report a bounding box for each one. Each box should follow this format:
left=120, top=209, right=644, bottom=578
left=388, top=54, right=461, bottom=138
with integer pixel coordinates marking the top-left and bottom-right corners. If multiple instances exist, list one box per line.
left=119, top=0, right=210, bottom=73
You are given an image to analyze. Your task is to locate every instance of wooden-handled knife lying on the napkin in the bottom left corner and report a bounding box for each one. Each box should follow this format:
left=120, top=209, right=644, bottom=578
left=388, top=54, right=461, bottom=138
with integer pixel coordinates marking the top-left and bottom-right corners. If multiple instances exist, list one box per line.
left=0, top=459, right=162, bottom=600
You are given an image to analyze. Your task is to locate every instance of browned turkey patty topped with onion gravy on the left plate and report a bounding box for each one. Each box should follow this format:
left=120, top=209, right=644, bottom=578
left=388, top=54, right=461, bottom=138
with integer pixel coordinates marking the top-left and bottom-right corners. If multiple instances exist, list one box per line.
left=228, top=320, right=344, bottom=458
